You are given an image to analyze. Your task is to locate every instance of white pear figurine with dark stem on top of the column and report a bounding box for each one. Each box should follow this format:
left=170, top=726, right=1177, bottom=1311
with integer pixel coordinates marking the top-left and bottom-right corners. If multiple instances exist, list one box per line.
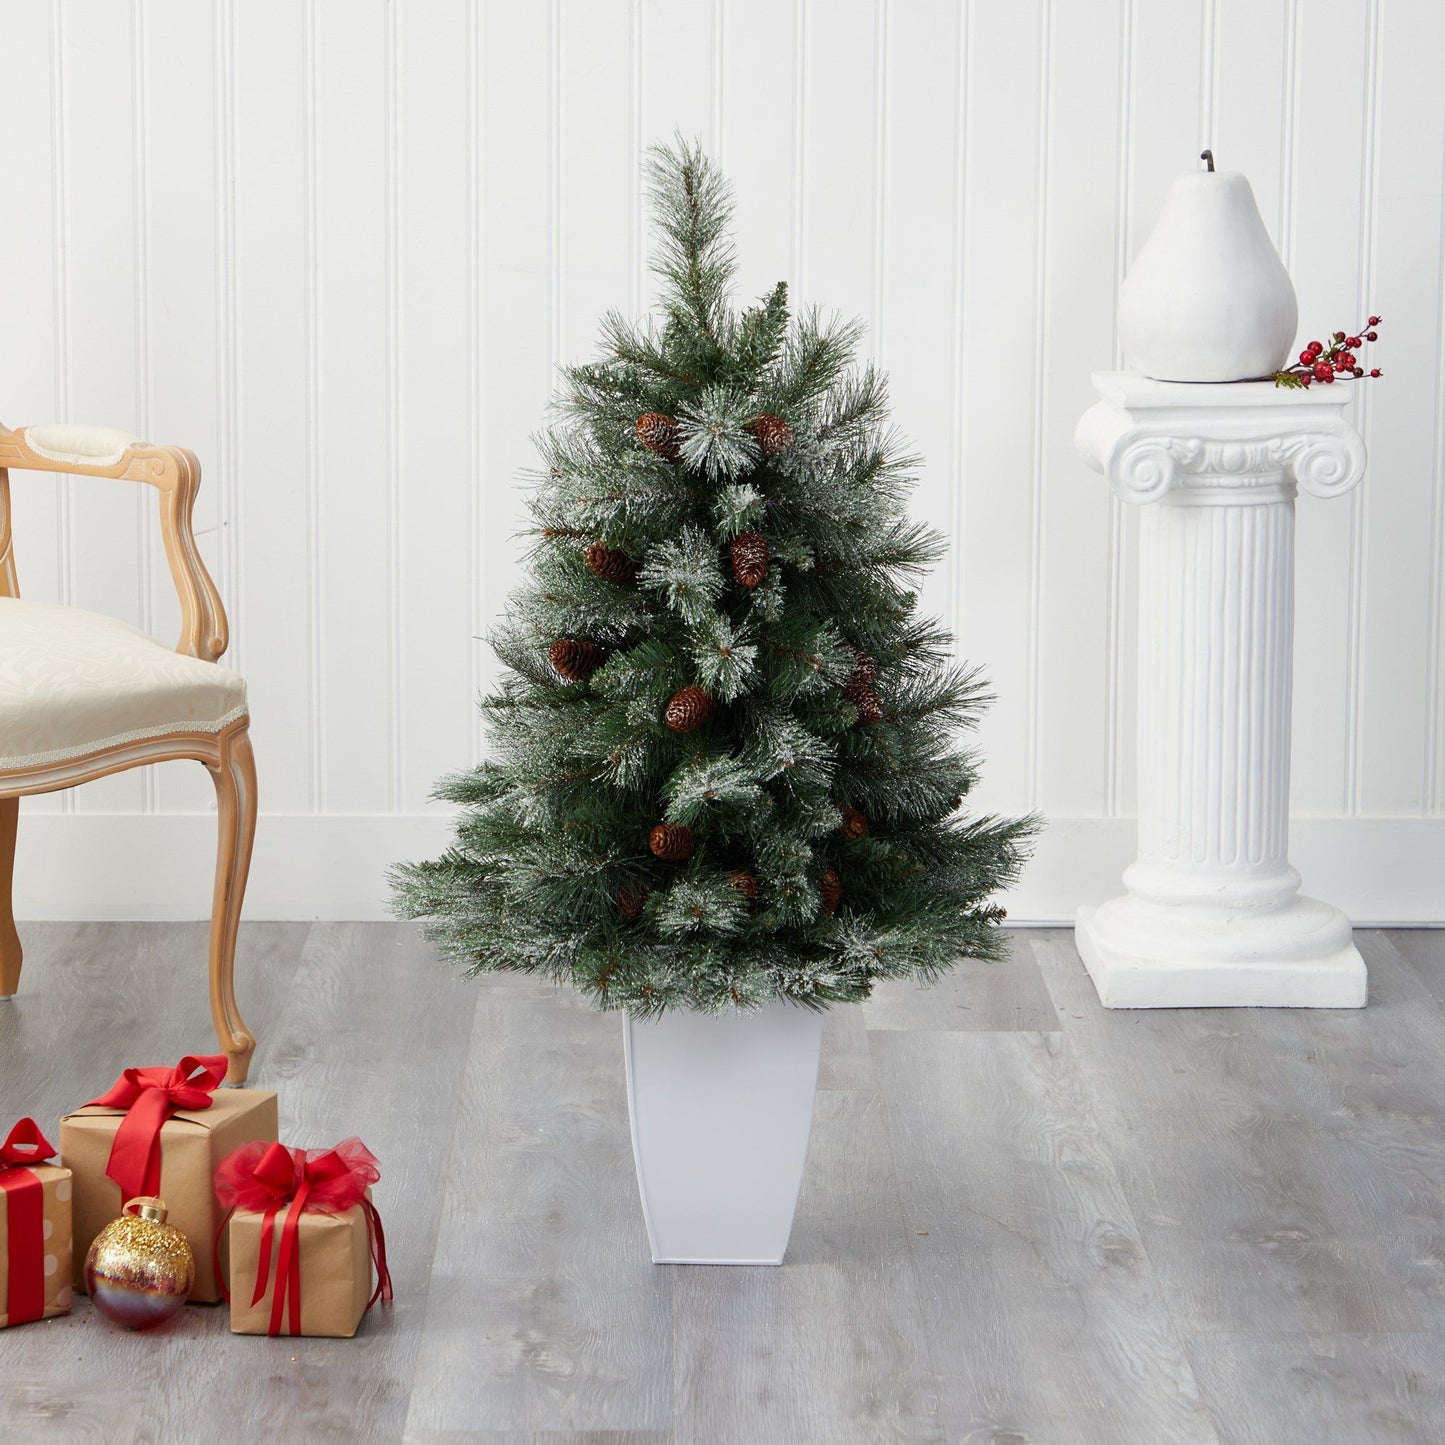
left=1118, top=150, right=1299, bottom=381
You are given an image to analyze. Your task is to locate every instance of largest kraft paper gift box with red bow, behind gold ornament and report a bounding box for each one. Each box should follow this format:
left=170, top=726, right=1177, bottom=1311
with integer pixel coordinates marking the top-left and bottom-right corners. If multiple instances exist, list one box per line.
left=61, top=1055, right=277, bottom=1303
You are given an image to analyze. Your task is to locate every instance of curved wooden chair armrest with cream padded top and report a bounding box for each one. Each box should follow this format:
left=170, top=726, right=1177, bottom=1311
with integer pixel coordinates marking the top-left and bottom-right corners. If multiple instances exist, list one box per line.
left=0, top=426, right=230, bottom=662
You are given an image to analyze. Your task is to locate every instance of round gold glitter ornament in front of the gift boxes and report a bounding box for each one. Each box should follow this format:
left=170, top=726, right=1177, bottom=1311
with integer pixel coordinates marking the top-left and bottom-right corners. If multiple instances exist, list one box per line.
left=85, top=1196, right=195, bottom=1329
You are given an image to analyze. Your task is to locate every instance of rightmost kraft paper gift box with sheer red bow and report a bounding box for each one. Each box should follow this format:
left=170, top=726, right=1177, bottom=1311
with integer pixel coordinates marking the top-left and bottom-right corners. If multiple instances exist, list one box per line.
left=215, top=1139, right=392, bottom=1338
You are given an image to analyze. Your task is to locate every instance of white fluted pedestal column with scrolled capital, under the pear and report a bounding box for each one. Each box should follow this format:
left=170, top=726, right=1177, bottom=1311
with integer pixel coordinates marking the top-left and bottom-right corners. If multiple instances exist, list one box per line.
left=1075, top=373, right=1366, bottom=1009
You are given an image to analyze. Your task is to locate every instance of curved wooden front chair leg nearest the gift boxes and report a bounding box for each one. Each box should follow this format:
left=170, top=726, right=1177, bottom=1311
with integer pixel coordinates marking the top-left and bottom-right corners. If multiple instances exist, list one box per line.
left=207, top=720, right=256, bottom=1084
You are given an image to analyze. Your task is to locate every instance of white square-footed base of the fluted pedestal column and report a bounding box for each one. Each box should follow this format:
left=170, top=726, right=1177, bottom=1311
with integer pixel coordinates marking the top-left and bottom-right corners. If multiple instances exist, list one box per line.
left=1074, top=896, right=1367, bottom=1009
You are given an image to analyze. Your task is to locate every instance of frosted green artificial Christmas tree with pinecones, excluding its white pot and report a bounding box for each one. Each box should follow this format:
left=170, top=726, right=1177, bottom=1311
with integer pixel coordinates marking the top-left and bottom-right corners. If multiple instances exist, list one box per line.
left=396, top=145, right=1032, bottom=1017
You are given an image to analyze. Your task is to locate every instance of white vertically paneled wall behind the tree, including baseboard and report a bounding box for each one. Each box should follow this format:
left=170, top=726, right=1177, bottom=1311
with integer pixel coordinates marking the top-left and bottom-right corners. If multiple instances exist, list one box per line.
left=0, top=0, right=1445, bottom=919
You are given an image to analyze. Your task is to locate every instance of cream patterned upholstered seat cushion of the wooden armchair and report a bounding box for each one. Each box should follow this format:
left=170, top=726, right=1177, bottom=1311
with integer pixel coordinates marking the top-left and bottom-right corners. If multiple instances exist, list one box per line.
left=0, top=597, right=246, bottom=769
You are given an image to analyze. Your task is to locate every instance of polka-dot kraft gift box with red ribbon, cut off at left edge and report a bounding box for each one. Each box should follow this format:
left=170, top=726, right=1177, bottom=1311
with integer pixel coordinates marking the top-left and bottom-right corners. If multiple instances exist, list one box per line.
left=0, top=1118, right=71, bottom=1329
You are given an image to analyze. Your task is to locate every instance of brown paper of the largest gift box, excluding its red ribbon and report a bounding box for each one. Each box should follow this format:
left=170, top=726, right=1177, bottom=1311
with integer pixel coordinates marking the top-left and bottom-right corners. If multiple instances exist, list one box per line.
left=61, top=1059, right=277, bottom=1302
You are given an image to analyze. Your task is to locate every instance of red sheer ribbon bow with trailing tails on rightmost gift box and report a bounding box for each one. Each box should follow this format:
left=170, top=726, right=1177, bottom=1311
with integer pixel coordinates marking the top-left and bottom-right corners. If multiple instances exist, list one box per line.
left=215, top=1137, right=392, bottom=1335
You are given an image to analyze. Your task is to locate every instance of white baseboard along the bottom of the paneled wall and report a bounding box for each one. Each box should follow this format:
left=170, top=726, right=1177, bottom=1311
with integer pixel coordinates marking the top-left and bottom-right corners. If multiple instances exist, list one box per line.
left=14, top=803, right=1445, bottom=925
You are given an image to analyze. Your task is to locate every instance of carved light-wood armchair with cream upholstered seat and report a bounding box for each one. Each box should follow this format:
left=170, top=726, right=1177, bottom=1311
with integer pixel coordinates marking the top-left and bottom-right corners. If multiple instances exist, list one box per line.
left=0, top=426, right=256, bottom=1084
